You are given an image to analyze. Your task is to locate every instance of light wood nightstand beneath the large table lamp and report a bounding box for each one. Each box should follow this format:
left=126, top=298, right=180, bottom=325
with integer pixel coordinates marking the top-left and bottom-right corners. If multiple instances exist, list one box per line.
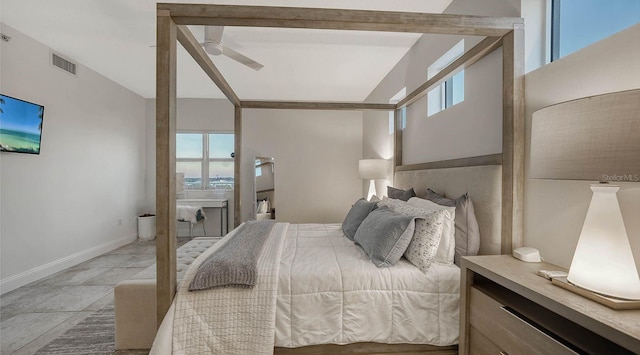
left=459, top=255, right=640, bottom=355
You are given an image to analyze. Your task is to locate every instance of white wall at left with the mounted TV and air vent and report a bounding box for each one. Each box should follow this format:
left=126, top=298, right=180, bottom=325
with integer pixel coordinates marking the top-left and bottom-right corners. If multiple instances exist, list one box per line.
left=0, top=24, right=146, bottom=292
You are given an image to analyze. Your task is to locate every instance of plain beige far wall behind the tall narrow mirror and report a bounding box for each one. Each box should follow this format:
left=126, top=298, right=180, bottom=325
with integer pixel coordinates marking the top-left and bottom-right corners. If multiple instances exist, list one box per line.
left=241, top=109, right=362, bottom=223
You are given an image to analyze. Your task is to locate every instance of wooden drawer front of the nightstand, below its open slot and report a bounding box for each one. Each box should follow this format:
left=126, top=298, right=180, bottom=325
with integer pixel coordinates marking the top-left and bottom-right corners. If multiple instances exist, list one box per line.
left=469, top=287, right=576, bottom=354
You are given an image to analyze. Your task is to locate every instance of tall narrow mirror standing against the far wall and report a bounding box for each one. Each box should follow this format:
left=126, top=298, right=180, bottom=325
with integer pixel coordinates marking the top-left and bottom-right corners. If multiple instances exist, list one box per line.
left=253, top=157, right=276, bottom=220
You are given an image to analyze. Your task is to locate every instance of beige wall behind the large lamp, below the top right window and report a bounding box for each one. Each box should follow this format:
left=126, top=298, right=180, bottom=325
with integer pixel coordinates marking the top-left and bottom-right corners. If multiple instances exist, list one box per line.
left=525, top=25, right=640, bottom=267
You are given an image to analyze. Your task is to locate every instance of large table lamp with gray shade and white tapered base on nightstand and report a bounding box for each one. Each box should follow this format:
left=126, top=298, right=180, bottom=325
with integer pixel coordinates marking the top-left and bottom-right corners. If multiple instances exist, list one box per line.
left=529, top=90, right=640, bottom=304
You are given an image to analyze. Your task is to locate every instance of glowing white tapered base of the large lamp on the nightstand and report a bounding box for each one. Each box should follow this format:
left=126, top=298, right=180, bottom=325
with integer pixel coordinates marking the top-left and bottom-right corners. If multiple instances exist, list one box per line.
left=567, top=184, right=640, bottom=300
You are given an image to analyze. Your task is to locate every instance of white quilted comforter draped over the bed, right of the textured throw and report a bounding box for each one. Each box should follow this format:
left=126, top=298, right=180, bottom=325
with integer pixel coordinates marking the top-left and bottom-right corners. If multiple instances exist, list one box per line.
left=275, top=224, right=460, bottom=347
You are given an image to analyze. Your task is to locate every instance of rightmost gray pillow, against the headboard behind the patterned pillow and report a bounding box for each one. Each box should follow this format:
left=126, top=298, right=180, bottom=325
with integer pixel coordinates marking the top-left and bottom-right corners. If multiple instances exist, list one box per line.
left=427, top=189, right=480, bottom=265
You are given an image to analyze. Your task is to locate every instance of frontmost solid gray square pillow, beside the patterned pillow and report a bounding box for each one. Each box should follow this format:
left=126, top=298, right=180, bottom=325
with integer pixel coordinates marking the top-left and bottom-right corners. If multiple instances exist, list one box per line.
left=354, top=206, right=416, bottom=267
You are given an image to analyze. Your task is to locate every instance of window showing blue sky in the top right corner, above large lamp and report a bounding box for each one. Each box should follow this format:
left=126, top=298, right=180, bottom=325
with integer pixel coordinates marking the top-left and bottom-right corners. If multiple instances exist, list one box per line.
left=551, top=0, right=640, bottom=61
